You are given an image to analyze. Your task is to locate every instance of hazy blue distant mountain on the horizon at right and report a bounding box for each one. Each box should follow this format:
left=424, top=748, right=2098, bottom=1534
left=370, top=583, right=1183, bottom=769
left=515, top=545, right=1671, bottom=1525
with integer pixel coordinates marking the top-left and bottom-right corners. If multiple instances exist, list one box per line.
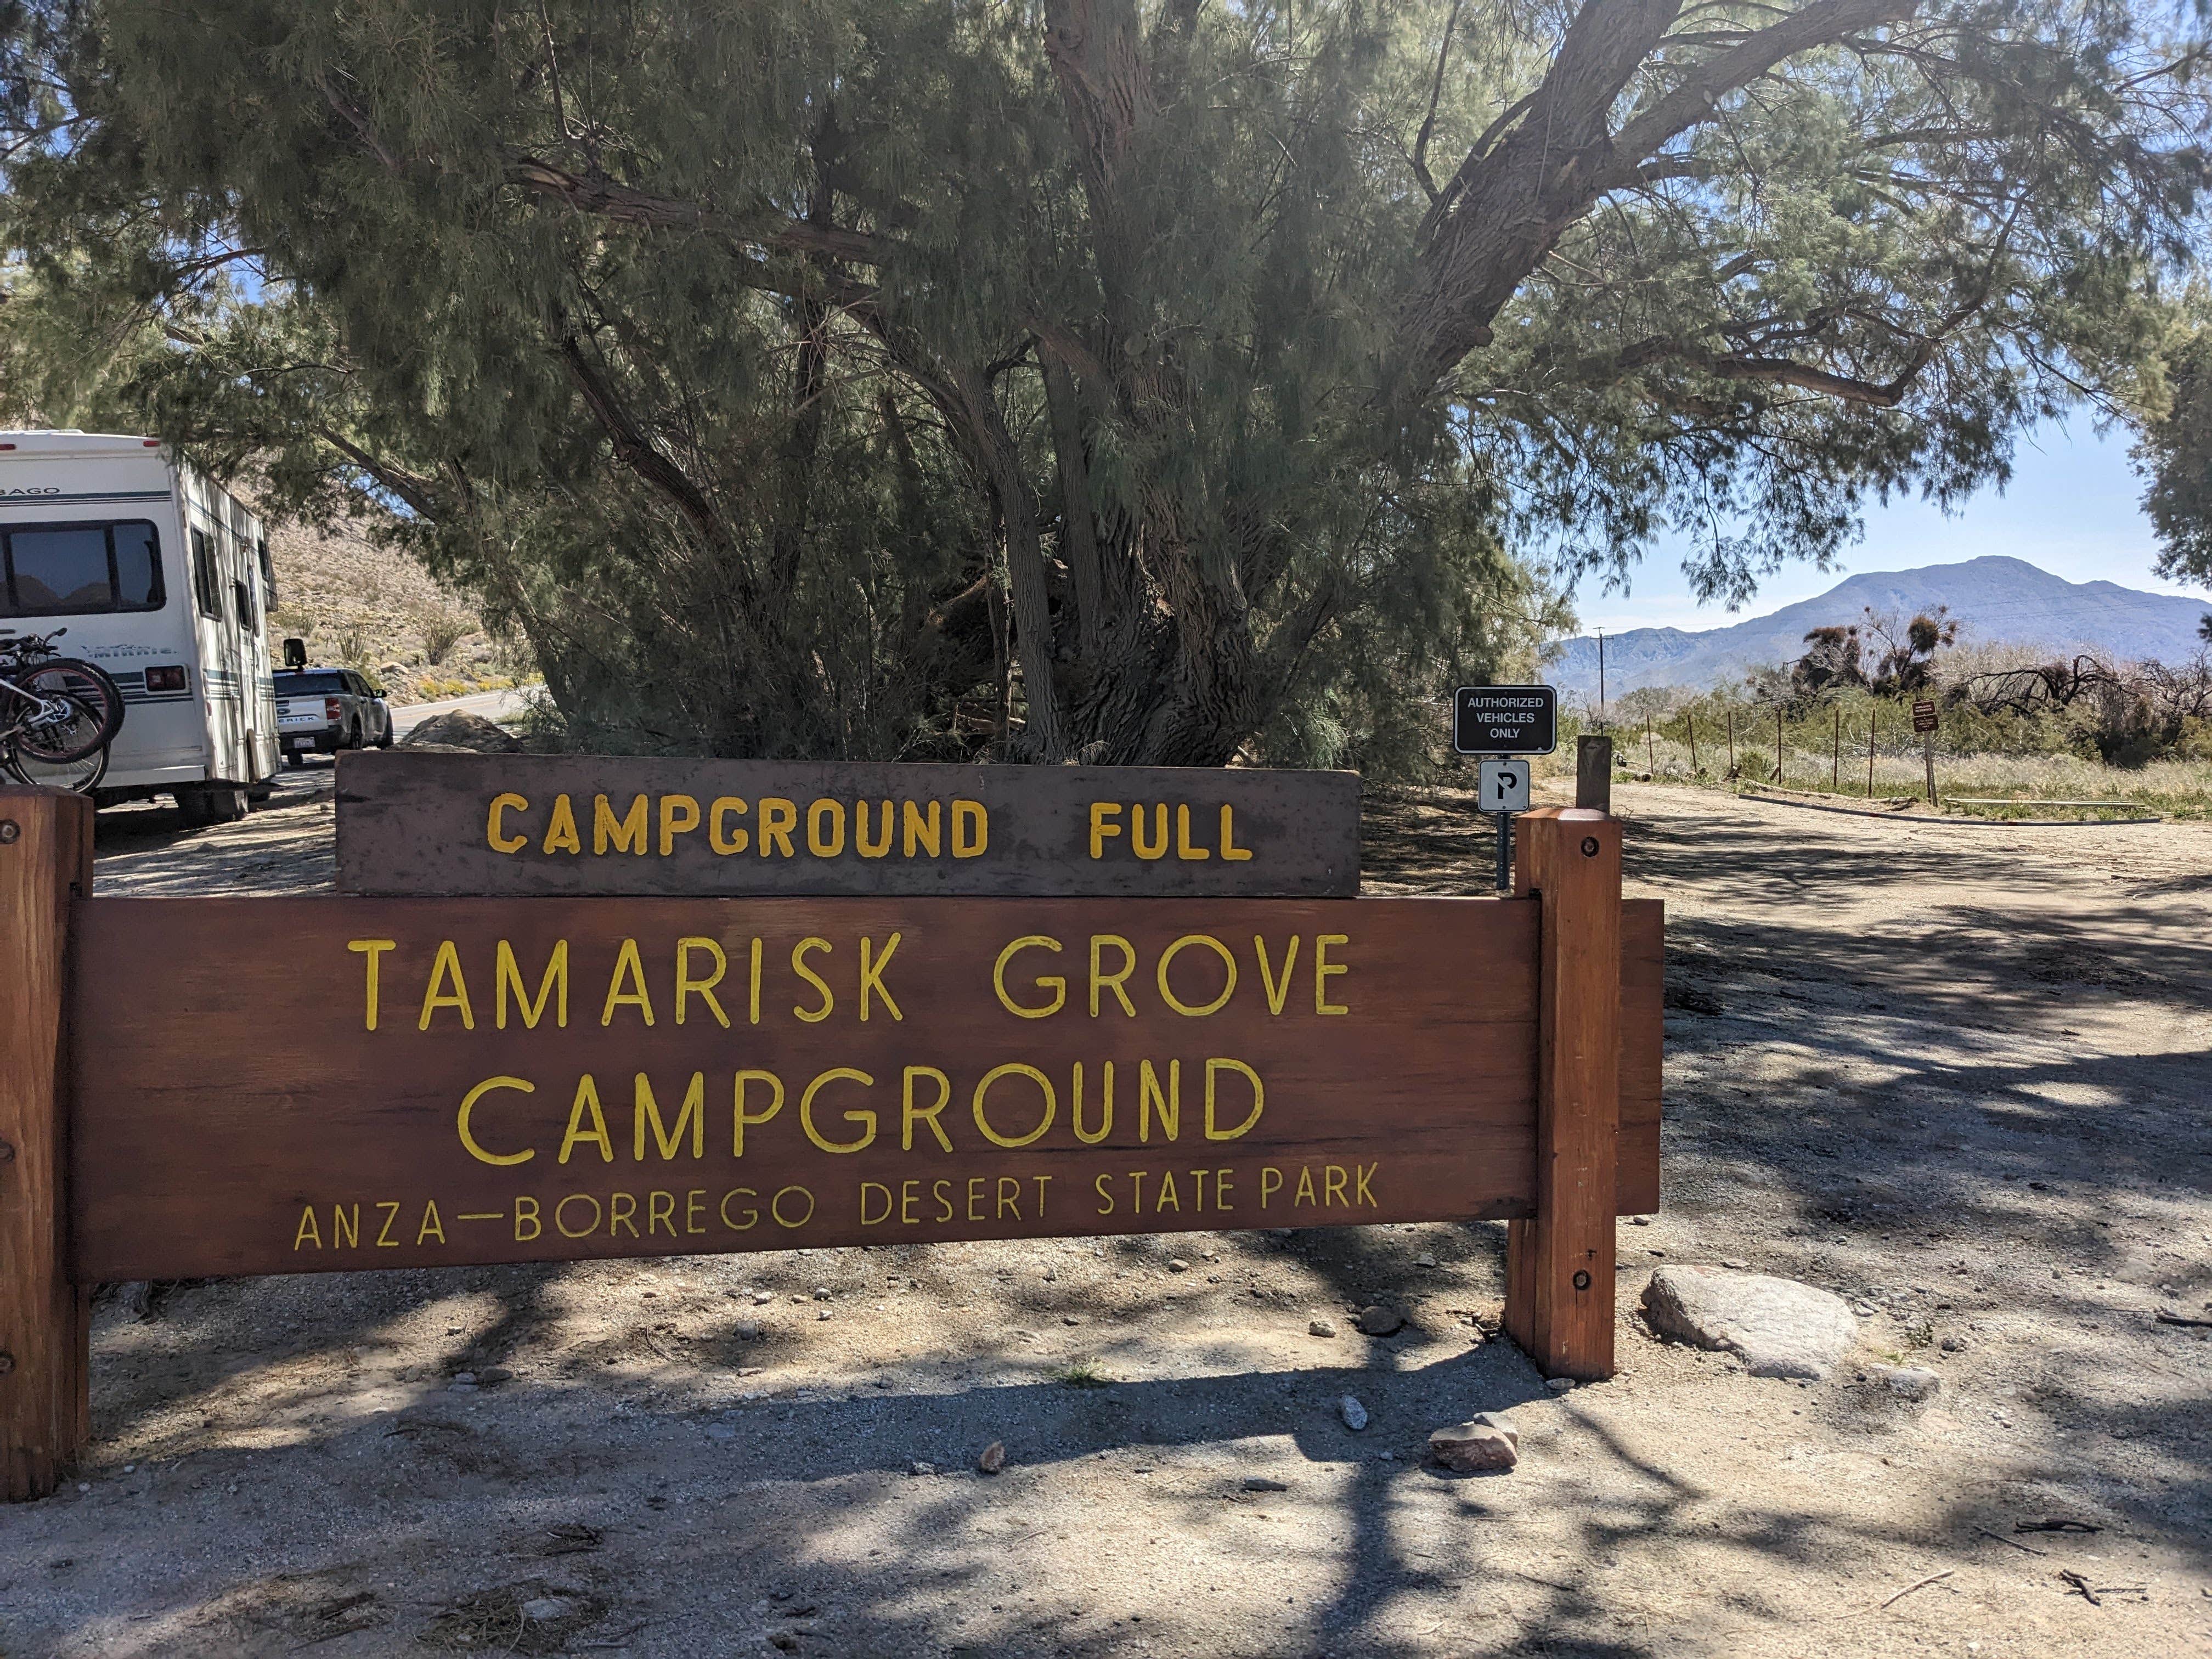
left=1544, top=557, right=2212, bottom=701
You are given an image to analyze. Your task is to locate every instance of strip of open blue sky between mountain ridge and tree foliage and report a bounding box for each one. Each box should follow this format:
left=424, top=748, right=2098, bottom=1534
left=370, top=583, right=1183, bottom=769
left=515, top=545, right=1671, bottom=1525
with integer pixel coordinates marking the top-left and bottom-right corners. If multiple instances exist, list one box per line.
left=1575, top=418, right=2205, bottom=633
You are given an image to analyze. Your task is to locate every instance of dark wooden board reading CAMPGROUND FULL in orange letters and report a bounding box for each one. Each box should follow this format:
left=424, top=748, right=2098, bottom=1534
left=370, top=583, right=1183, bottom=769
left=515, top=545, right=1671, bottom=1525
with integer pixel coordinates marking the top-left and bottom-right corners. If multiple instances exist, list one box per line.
left=338, top=752, right=1361, bottom=898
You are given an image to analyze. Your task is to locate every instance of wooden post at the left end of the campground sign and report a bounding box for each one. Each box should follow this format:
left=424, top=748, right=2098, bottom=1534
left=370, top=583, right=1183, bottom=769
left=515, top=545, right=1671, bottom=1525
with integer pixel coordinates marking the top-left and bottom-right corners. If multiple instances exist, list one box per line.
left=0, top=787, right=93, bottom=1502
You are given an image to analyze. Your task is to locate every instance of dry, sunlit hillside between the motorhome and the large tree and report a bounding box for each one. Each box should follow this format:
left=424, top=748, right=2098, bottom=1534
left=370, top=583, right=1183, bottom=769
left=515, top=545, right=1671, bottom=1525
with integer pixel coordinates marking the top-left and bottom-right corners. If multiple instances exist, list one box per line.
left=270, top=524, right=517, bottom=703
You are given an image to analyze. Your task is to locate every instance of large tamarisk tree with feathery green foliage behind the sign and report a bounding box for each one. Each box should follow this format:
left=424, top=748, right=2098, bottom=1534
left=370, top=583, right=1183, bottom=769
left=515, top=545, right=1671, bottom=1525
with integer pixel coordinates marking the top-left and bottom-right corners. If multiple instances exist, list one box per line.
left=0, top=0, right=2205, bottom=765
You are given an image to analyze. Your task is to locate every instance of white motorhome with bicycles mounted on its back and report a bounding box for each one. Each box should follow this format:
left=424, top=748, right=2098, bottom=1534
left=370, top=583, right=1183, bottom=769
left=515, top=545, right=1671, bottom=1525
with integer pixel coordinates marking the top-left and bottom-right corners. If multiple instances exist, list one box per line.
left=0, top=431, right=276, bottom=823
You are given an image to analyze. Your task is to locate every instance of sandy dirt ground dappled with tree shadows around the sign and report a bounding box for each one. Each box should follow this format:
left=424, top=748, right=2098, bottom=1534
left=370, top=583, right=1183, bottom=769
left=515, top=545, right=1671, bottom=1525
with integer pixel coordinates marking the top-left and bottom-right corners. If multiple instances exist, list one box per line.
left=0, top=768, right=2212, bottom=1659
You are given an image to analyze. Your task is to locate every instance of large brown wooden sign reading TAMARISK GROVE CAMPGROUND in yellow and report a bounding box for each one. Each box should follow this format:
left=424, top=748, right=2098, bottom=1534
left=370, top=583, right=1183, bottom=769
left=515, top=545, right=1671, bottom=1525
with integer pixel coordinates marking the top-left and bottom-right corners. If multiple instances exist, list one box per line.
left=69, top=898, right=1661, bottom=1283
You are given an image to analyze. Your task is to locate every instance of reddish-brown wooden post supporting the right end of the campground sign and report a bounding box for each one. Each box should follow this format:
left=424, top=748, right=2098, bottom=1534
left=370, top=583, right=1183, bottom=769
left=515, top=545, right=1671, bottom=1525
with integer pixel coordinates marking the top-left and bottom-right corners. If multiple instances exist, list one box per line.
left=1506, top=808, right=1621, bottom=1383
